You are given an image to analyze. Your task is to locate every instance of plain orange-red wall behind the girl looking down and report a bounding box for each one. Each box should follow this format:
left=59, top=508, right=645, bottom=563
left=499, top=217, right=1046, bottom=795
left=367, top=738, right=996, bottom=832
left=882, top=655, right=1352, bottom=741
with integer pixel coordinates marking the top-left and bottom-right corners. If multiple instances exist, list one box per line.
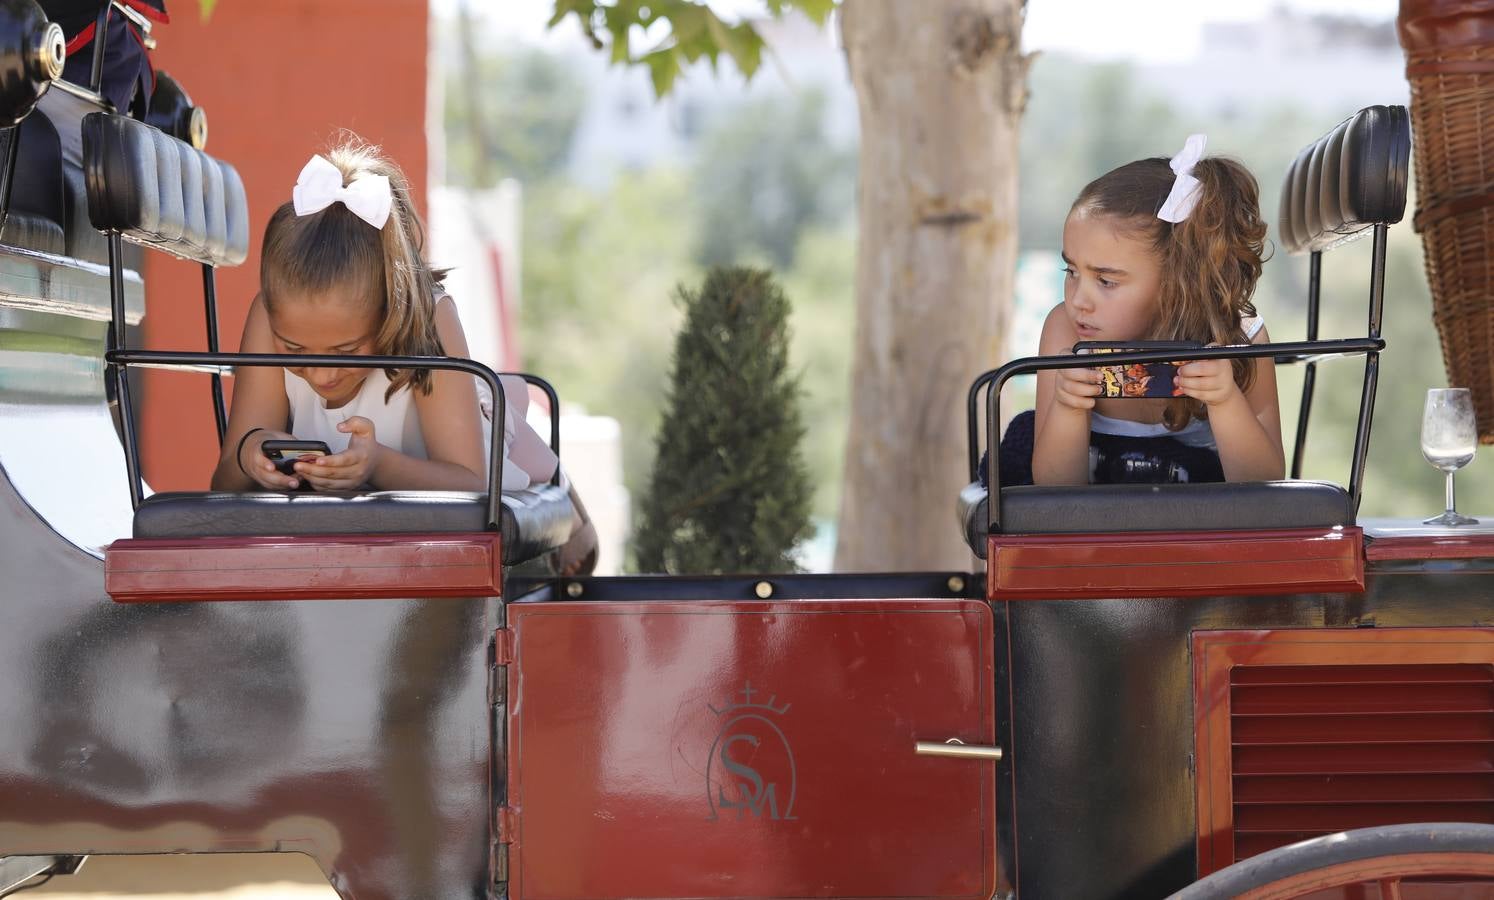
left=142, top=0, right=429, bottom=490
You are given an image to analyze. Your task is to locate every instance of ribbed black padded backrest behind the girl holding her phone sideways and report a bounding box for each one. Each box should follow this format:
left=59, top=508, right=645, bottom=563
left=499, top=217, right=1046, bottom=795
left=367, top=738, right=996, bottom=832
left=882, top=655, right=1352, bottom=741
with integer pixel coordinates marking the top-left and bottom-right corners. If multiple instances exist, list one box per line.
left=1277, top=106, right=1410, bottom=253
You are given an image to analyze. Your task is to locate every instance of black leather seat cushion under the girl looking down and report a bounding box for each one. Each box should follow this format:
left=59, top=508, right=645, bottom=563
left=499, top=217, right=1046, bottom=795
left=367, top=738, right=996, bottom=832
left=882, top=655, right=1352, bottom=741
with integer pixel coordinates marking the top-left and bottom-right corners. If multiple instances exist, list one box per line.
left=134, top=484, right=575, bottom=565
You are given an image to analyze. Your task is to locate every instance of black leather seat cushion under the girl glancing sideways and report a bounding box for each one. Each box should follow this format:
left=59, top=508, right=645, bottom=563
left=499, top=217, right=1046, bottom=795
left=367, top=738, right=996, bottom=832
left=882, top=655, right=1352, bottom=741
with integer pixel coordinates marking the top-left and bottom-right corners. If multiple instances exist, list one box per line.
left=959, top=481, right=1354, bottom=559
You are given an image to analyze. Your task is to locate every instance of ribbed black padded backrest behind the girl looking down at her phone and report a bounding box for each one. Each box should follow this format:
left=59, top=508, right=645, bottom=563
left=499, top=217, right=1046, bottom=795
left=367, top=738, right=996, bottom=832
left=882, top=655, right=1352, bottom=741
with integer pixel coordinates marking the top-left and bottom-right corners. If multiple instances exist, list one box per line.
left=82, top=112, right=249, bottom=266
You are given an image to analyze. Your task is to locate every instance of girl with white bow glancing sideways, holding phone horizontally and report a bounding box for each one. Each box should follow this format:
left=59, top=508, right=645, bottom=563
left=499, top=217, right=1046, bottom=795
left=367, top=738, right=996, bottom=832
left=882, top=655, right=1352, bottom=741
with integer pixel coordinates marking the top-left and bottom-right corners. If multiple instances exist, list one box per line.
left=1021, top=135, right=1285, bottom=484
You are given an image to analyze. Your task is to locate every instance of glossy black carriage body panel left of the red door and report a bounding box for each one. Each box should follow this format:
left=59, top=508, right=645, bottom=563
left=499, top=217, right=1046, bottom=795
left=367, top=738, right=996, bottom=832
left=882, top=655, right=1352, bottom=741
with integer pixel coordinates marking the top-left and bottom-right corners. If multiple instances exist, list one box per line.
left=0, top=463, right=496, bottom=900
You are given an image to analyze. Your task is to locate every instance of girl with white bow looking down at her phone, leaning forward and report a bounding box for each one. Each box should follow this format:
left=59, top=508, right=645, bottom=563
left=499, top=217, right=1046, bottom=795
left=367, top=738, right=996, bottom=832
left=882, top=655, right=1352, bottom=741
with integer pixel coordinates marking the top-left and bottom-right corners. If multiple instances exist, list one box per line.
left=212, top=141, right=582, bottom=529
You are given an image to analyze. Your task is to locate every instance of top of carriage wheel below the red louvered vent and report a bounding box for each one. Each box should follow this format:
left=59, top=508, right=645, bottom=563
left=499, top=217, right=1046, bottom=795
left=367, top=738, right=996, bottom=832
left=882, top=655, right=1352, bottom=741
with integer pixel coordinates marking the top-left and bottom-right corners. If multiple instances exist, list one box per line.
left=1171, top=822, right=1494, bottom=900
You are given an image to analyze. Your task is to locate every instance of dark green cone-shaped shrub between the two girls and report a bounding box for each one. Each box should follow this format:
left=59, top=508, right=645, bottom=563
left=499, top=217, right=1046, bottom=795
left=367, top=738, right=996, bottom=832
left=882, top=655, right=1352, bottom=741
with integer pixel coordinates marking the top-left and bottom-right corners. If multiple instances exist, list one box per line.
left=635, top=268, right=811, bottom=574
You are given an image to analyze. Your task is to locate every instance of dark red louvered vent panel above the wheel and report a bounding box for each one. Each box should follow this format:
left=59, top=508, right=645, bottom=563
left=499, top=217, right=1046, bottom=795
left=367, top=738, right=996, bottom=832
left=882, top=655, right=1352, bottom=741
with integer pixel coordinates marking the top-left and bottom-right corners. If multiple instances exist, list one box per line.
left=1230, top=664, right=1494, bottom=860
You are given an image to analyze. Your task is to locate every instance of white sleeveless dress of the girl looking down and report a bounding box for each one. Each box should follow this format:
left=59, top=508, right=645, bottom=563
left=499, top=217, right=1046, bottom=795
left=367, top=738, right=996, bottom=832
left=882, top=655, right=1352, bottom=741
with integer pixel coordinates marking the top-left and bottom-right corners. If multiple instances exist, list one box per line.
left=284, top=369, right=557, bottom=490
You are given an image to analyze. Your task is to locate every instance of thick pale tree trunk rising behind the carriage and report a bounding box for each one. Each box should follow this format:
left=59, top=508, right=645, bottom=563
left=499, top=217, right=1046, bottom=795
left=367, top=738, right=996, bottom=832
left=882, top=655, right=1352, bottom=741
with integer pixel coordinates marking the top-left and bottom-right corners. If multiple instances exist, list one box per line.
left=835, top=0, right=1028, bottom=571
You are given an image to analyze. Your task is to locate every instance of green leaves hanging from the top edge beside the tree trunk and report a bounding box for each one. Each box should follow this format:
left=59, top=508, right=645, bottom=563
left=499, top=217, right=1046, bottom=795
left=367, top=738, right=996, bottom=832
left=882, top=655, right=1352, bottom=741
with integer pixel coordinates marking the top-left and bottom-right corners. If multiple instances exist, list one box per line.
left=550, top=0, right=838, bottom=97
